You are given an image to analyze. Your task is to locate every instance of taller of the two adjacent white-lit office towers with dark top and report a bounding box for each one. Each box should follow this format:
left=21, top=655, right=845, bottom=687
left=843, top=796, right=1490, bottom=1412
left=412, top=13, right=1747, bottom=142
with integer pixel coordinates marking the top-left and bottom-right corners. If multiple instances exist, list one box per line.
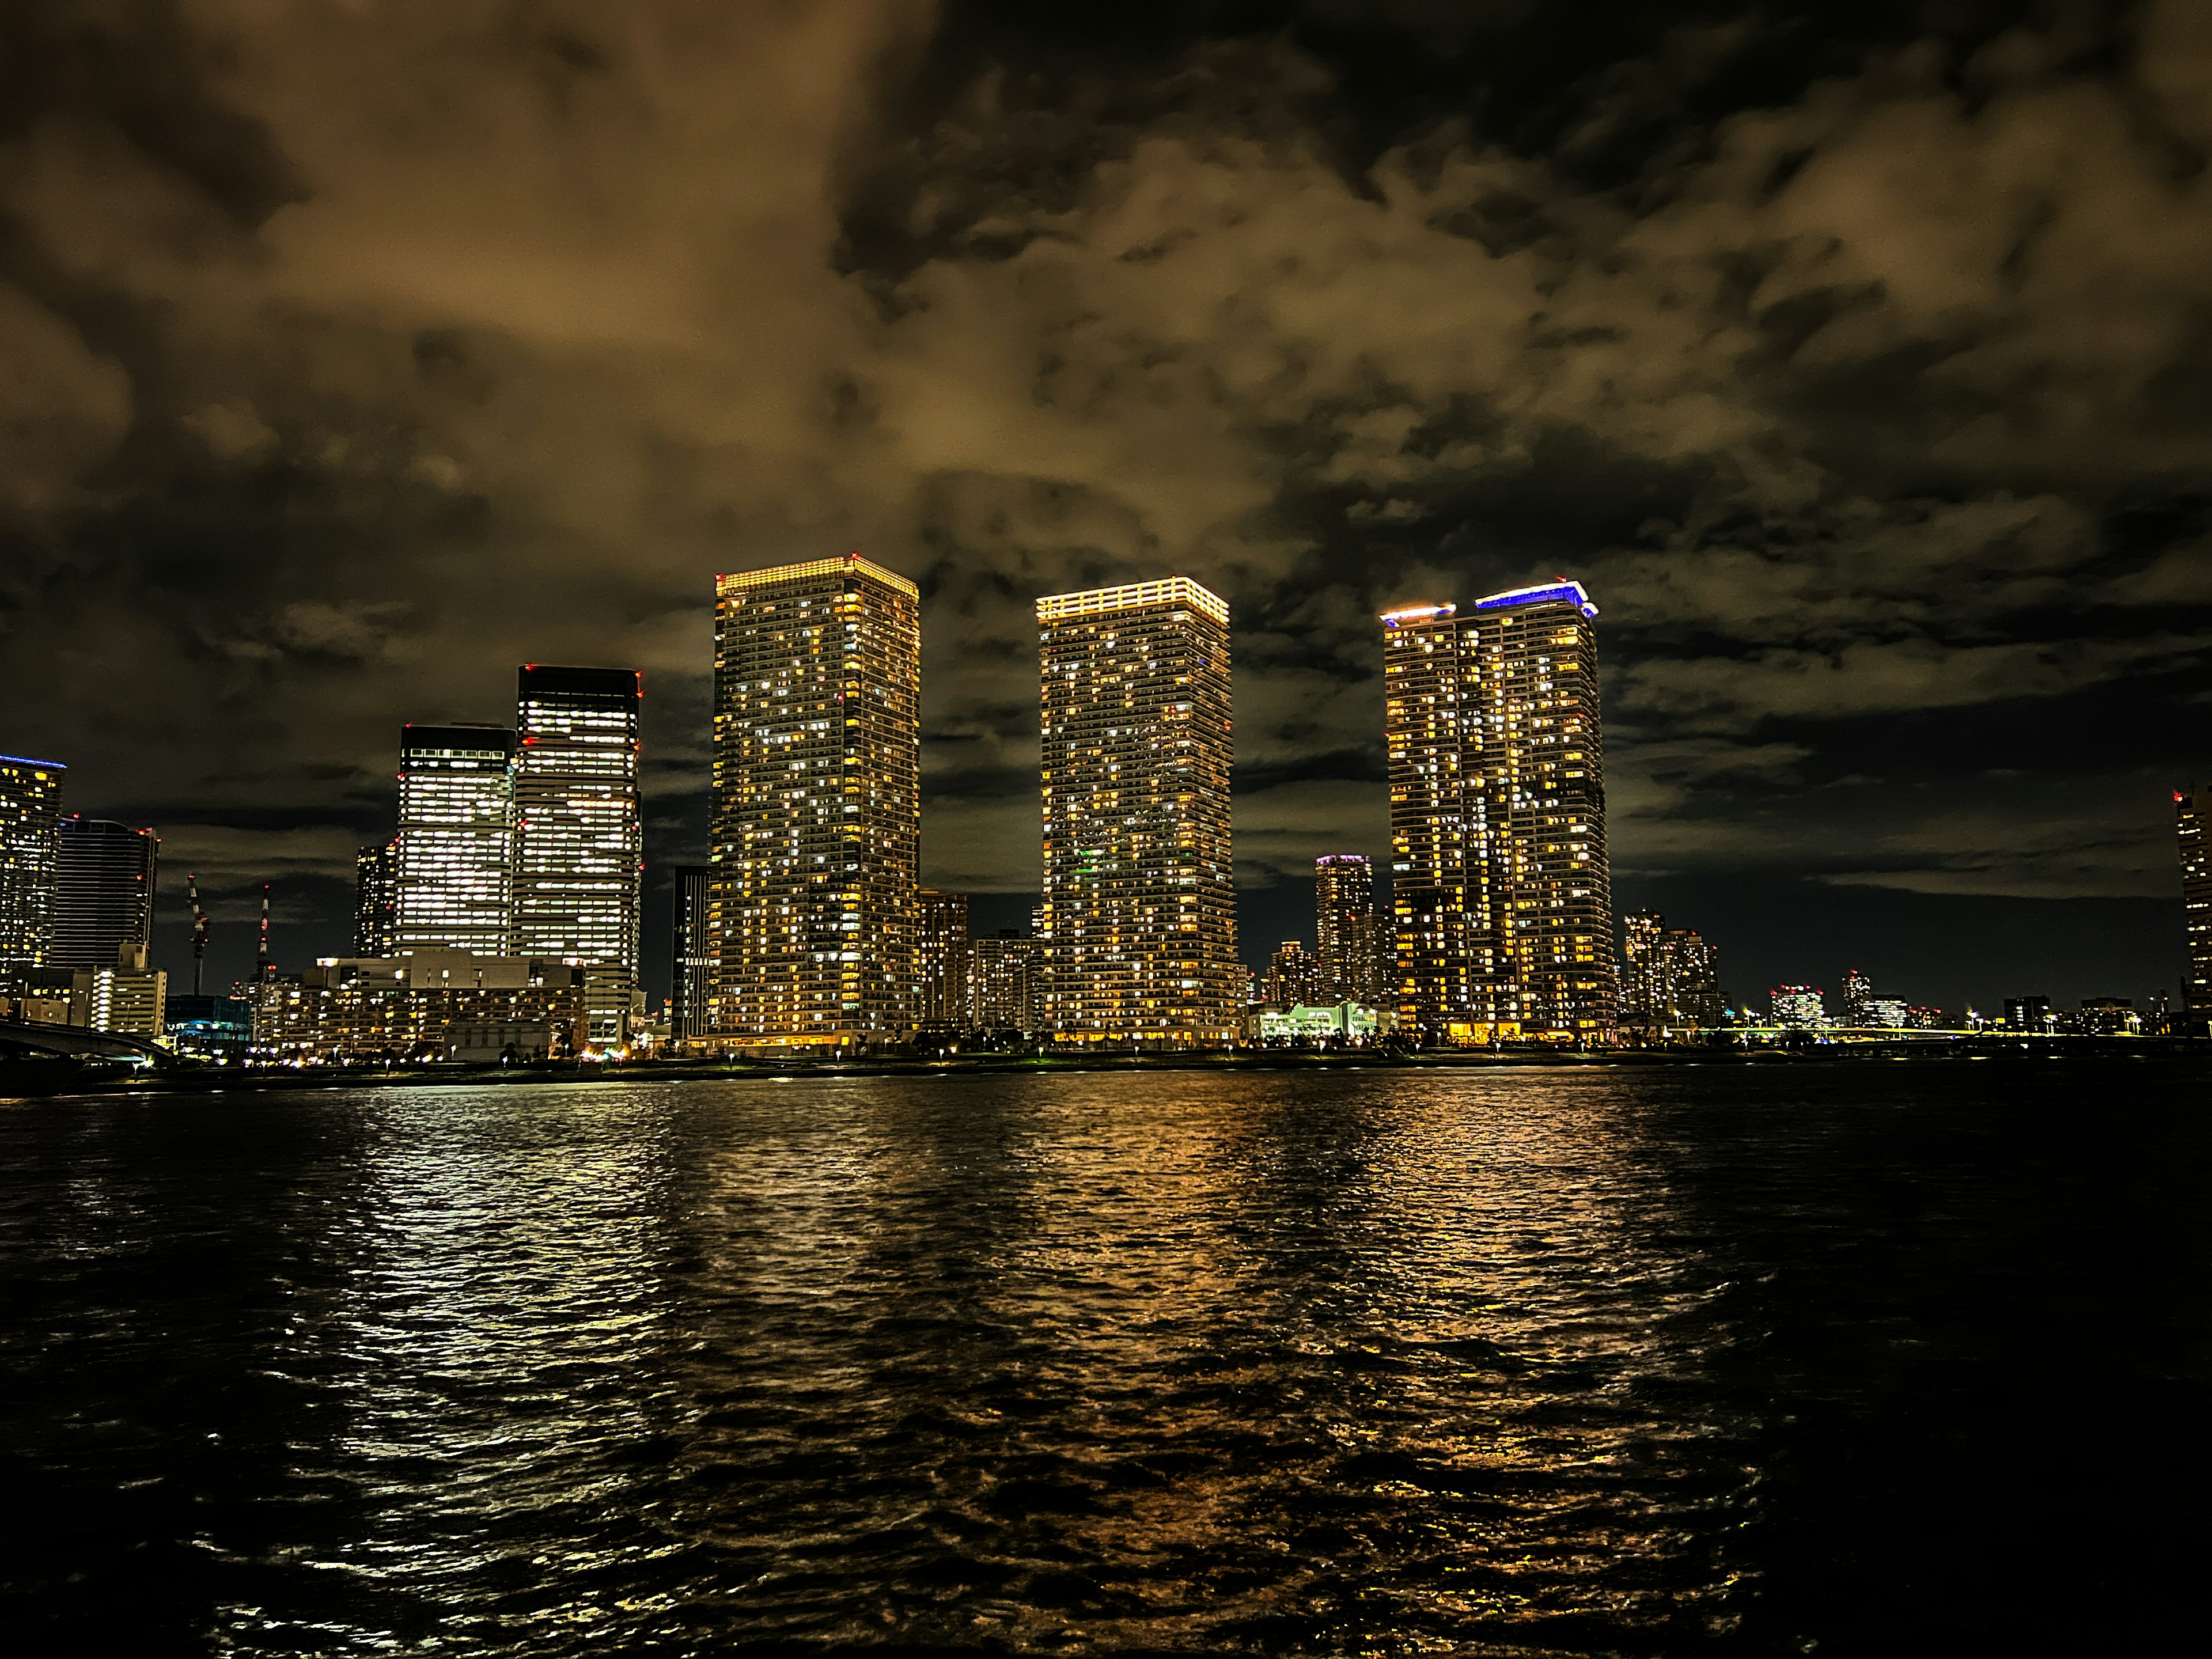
left=511, top=664, right=643, bottom=975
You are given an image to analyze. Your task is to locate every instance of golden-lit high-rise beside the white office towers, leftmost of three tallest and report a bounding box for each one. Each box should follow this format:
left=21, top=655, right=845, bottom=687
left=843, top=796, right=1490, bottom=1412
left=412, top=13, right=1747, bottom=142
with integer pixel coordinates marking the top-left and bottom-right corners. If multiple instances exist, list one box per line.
left=708, top=553, right=922, bottom=1048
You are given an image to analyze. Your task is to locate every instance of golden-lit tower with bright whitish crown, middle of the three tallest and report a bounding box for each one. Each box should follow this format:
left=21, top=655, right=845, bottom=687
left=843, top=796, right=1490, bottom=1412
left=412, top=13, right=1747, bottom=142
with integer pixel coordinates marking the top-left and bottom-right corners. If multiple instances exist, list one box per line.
left=1037, top=575, right=1243, bottom=1046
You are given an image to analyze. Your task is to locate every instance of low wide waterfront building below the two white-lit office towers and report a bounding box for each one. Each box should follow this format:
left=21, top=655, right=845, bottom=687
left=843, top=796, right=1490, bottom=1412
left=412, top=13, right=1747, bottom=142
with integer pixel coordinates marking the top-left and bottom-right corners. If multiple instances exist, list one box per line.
left=252, top=947, right=590, bottom=1064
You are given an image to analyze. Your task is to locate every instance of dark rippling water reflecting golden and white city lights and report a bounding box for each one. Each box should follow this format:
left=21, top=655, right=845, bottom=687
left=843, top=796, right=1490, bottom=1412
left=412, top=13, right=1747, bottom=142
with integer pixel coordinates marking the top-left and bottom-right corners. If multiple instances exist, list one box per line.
left=0, top=1062, right=2212, bottom=1657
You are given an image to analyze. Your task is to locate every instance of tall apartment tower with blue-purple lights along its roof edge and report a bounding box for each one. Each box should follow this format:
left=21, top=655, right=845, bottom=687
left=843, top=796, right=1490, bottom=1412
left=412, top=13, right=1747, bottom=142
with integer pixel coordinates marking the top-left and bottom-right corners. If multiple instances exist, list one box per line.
left=1382, top=579, right=1617, bottom=1042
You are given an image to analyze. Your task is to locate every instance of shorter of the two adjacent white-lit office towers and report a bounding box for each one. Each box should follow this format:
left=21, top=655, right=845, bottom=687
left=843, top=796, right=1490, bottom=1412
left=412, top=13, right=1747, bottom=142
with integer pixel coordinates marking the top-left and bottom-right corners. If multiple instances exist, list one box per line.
left=392, top=726, right=516, bottom=956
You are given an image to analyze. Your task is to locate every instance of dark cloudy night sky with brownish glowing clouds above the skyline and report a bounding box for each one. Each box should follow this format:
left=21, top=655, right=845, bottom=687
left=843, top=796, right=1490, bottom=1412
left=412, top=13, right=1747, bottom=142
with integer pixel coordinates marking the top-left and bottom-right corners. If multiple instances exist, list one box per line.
left=0, top=0, right=2212, bottom=1006
